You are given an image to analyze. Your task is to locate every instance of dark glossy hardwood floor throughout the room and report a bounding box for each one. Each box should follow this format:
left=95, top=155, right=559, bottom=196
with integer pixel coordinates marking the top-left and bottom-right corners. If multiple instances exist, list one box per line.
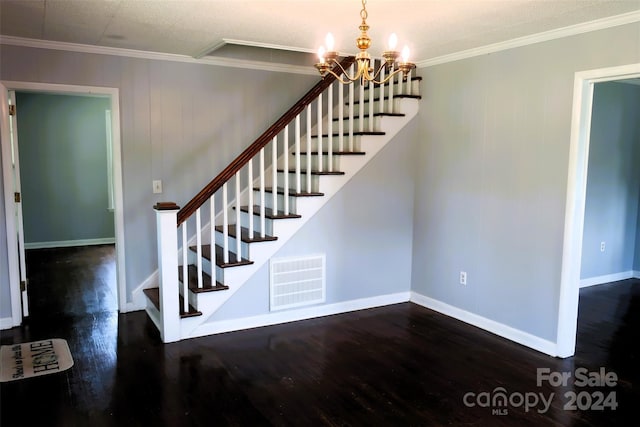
left=0, top=246, right=640, bottom=427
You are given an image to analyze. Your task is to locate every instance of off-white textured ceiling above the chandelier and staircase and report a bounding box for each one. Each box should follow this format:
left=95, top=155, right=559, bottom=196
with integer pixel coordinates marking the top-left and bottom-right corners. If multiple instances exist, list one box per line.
left=0, top=0, right=640, bottom=62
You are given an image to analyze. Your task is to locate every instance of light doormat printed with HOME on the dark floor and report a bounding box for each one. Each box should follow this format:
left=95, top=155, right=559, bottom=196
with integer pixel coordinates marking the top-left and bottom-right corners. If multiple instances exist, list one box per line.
left=0, top=338, right=73, bottom=382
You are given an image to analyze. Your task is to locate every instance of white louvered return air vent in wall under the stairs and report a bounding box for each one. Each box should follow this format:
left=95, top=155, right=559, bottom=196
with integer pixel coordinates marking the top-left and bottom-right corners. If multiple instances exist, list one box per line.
left=270, top=255, right=326, bottom=311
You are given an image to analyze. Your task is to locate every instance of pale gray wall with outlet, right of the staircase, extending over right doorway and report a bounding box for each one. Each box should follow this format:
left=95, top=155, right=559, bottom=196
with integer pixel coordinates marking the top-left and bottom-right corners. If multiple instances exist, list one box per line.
left=412, top=23, right=640, bottom=342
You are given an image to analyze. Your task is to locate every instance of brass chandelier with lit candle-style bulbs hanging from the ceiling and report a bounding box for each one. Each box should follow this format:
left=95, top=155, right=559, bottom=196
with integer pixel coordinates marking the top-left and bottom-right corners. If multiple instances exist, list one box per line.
left=316, top=0, right=416, bottom=84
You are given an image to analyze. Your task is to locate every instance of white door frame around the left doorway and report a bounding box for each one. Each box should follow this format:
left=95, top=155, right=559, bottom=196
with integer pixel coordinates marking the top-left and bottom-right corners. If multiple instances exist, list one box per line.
left=0, top=81, right=127, bottom=320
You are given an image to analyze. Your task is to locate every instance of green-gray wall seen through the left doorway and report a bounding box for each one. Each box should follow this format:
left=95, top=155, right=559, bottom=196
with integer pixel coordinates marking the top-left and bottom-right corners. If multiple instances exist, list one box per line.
left=16, top=92, right=115, bottom=244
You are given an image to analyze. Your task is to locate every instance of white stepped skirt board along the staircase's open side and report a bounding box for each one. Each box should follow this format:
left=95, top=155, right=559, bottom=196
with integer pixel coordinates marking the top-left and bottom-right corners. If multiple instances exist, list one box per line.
left=175, top=98, right=419, bottom=339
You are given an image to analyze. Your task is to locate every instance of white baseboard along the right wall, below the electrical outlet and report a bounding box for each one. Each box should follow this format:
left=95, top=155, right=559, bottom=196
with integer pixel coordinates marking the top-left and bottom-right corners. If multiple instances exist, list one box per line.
left=410, top=291, right=556, bottom=356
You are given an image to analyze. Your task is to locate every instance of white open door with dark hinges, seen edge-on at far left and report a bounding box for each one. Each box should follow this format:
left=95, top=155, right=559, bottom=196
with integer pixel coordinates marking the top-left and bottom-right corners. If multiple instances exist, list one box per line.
left=0, top=84, right=29, bottom=326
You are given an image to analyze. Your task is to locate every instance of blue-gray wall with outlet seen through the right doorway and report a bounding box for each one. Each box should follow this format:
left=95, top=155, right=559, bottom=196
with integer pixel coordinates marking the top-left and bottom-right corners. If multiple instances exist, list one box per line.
left=581, top=82, right=640, bottom=279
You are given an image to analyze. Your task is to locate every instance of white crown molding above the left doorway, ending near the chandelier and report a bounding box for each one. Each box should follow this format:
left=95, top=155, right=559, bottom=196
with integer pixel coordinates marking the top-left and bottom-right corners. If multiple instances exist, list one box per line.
left=0, top=35, right=318, bottom=76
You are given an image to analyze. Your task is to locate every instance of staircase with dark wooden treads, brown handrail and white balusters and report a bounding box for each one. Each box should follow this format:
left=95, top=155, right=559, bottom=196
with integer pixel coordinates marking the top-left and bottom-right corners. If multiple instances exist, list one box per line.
left=144, top=57, right=420, bottom=342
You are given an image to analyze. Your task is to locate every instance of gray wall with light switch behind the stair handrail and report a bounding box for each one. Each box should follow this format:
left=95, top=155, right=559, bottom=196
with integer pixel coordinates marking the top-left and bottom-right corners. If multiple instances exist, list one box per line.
left=0, top=45, right=317, bottom=310
